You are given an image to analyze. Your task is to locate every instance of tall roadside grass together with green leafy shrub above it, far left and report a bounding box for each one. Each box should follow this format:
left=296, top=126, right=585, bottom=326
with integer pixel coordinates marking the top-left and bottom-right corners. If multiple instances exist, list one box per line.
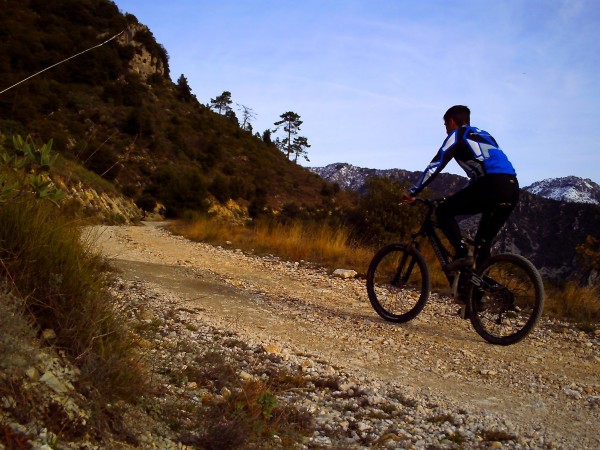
left=0, top=134, right=145, bottom=400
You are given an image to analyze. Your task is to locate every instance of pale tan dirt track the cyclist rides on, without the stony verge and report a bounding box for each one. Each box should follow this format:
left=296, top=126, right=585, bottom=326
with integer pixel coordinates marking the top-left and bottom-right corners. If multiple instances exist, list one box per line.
left=94, top=223, right=600, bottom=448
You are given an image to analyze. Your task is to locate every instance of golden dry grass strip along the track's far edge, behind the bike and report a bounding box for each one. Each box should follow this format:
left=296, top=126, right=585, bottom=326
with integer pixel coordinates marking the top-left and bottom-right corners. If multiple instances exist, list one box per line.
left=171, top=214, right=600, bottom=329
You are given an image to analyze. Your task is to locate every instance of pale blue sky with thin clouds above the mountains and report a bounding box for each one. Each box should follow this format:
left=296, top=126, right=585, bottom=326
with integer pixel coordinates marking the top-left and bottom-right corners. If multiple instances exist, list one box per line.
left=115, top=0, right=600, bottom=186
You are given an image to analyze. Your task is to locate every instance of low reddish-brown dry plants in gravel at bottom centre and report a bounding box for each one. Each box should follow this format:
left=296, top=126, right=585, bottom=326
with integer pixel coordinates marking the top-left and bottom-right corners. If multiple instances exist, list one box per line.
left=162, top=346, right=314, bottom=448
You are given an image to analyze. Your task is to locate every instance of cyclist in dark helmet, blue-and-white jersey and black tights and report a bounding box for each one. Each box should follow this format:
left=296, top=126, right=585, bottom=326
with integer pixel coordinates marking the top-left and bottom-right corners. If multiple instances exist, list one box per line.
left=405, top=105, right=519, bottom=271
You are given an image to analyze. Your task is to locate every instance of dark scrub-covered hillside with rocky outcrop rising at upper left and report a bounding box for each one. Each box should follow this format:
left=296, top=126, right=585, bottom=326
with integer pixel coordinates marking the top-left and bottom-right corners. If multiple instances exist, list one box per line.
left=0, top=0, right=342, bottom=215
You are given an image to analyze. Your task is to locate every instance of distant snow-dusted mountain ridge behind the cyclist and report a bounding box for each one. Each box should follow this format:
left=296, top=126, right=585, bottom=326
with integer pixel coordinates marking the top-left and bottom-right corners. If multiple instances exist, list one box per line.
left=310, top=163, right=600, bottom=279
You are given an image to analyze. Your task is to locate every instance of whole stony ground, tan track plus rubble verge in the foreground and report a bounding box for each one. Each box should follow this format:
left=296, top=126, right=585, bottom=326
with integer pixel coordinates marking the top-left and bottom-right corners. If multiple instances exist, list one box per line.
left=1, top=223, right=600, bottom=449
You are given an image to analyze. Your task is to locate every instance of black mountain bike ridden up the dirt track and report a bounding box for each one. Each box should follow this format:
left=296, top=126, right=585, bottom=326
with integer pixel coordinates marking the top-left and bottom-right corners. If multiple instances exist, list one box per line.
left=367, top=198, right=544, bottom=345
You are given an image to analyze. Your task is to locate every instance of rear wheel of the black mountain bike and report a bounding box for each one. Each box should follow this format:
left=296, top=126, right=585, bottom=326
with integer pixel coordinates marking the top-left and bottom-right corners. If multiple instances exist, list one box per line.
left=469, top=253, right=544, bottom=345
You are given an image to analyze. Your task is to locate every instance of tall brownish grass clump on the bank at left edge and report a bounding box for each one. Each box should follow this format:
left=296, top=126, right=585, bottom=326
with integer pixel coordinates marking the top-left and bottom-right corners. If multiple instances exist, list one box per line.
left=0, top=200, right=145, bottom=401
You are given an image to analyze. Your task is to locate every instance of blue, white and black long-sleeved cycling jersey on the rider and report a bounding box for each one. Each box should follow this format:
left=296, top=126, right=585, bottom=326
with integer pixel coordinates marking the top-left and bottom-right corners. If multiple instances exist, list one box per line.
left=408, top=125, right=516, bottom=196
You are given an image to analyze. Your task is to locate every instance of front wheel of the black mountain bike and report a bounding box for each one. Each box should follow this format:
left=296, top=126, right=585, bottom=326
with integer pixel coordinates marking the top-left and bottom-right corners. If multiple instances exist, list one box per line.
left=367, top=244, right=429, bottom=323
